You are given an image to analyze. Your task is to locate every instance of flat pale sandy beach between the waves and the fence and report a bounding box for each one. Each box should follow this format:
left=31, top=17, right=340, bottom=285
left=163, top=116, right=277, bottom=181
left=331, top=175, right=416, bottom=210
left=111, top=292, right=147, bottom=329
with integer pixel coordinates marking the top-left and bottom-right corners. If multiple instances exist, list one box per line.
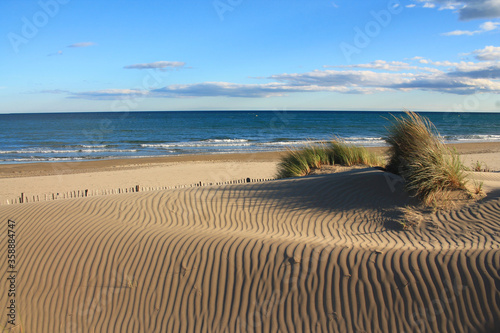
left=0, top=143, right=500, bottom=205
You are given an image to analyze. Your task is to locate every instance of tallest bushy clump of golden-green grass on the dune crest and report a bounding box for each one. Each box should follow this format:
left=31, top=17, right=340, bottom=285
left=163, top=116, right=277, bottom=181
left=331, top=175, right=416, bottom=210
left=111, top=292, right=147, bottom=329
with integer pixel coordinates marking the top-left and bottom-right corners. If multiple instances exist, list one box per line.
left=385, top=111, right=467, bottom=205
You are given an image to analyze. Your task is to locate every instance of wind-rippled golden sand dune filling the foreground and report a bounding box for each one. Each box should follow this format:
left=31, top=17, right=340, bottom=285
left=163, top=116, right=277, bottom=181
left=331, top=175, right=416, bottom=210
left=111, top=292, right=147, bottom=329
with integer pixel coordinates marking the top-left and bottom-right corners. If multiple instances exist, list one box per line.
left=0, top=169, right=500, bottom=332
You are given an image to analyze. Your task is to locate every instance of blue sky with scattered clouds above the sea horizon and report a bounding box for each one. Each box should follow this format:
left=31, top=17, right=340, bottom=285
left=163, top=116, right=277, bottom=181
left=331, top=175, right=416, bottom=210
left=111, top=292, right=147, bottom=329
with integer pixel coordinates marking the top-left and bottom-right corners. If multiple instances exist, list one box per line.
left=0, top=0, right=500, bottom=113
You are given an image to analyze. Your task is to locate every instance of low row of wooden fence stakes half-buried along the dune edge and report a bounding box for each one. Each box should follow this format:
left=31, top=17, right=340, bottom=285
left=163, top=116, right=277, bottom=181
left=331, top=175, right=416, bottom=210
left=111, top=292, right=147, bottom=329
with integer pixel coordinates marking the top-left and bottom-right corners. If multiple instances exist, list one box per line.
left=0, top=178, right=275, bottom=205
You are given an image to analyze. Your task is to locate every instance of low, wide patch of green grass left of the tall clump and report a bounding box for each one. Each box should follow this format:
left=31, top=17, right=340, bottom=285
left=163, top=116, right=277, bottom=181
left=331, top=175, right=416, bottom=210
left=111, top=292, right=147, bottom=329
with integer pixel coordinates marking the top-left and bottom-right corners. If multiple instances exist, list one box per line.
left=277, top=138, right=384, bottom=178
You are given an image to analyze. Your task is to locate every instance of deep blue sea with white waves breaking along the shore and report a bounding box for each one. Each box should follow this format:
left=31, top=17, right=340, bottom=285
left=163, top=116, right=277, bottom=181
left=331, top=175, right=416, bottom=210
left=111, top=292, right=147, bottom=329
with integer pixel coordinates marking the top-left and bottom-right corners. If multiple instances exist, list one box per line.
left=0, top=111, right=500, bottom=164
